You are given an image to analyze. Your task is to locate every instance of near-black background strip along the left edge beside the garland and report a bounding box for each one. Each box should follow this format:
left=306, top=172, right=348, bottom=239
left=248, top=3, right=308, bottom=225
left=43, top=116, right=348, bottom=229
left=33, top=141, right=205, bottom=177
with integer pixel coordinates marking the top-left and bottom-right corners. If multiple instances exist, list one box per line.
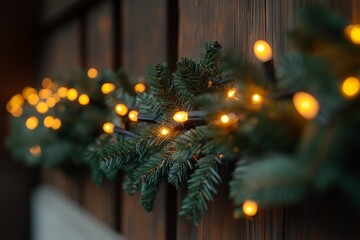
left=0, top=0, right=37, bottom=240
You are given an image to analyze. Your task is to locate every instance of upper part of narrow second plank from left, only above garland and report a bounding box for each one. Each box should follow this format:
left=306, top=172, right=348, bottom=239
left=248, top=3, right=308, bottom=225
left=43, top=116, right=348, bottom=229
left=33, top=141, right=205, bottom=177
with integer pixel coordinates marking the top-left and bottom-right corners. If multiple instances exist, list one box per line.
left=86, top=1, right=114, bottom=70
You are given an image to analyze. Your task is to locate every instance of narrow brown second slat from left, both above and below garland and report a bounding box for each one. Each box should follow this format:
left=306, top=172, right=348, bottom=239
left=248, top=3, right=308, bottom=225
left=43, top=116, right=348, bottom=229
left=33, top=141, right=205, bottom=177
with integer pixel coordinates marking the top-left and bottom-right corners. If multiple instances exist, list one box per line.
left=81, top=1, right=118, bottom=227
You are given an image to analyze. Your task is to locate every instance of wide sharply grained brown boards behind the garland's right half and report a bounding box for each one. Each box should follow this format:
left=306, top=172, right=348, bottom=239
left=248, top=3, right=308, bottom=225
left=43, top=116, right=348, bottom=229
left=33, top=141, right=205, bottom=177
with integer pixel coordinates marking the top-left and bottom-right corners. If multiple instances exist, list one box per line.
left=177, top=0, right=359, bottom=240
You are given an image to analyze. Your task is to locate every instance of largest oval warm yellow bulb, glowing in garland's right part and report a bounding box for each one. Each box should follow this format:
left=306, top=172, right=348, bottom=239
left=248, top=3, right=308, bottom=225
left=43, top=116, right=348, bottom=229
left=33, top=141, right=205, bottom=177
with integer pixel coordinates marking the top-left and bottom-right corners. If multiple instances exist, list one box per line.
left=293, top=92, right=320, bottom=120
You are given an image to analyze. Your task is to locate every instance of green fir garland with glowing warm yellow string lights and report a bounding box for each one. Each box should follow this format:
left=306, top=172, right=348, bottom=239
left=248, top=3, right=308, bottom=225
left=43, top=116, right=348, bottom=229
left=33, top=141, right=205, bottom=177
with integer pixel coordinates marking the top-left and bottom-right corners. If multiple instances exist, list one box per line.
left=4, top=8, right=360, bottom=223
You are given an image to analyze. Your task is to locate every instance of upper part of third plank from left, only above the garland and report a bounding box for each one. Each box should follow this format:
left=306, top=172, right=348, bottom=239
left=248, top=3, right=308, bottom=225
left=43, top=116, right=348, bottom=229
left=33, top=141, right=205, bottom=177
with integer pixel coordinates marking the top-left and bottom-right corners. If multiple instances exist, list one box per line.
left=121, top=0, right=167, bottom=77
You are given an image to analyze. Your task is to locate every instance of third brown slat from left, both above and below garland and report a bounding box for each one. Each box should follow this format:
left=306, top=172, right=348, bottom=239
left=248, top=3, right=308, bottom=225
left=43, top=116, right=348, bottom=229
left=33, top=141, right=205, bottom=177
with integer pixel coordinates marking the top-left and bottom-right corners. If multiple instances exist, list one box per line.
left=119, top=0, right=176, bottom=240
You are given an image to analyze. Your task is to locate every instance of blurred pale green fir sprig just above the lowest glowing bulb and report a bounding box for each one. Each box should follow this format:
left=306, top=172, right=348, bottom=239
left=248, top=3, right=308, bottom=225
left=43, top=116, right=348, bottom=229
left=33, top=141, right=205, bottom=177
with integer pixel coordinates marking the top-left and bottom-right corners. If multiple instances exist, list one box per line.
left=230, top=155, right=308, bottom=216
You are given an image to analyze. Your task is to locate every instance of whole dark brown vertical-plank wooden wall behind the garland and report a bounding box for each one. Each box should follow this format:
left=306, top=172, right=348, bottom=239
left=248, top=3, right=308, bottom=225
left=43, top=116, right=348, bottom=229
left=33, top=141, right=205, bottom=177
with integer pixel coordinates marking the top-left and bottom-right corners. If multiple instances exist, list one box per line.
left=39, top=0, right=360, bottom=240
